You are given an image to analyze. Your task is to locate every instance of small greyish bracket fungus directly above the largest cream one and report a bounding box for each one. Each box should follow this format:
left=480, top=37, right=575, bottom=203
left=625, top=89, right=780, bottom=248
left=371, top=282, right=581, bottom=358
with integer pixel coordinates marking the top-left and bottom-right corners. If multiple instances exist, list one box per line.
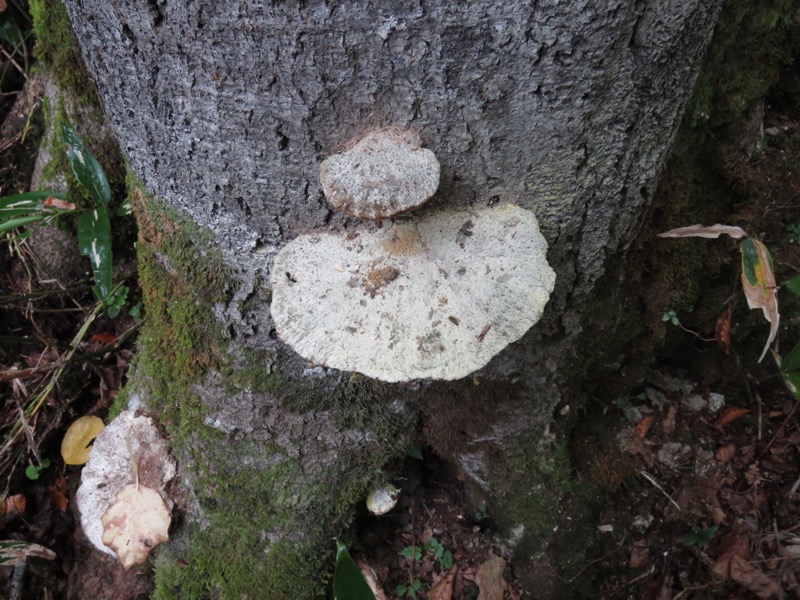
left=320, top=129, right=439, bottom=221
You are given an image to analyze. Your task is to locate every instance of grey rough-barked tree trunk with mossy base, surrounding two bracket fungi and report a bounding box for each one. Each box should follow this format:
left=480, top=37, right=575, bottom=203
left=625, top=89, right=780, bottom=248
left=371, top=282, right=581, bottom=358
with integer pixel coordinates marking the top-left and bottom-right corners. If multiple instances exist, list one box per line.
left=67, top=0, right=721, bottom=599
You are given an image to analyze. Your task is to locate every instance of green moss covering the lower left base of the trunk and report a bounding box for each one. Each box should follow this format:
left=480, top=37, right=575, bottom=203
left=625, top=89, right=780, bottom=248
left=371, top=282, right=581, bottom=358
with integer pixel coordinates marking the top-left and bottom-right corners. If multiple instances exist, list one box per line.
left=128, top=182, right=415, bottom=600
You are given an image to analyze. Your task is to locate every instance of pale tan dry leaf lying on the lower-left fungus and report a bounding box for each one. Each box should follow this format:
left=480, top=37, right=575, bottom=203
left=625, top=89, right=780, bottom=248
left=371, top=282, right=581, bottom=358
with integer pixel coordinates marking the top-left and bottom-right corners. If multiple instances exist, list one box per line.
left=101, top=483, right=170, bottom=570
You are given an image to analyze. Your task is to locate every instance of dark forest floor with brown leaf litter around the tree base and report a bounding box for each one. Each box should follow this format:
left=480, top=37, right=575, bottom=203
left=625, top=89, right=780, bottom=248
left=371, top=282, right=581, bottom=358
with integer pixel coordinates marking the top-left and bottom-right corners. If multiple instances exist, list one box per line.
left=0, top=5, right=800, bottom=600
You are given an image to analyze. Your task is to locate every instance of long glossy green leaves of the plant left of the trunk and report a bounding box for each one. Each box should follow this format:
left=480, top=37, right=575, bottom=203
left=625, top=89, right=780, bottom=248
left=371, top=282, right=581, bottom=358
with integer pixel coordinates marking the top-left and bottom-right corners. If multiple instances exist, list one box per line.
left=0, top=123, right=128, bottom=318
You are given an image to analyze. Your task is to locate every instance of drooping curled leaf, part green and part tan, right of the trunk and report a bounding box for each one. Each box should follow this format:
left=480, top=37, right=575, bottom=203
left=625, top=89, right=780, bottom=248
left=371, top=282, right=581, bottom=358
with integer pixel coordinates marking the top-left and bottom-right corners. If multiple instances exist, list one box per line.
left=739, top=238, right=780, bottom=362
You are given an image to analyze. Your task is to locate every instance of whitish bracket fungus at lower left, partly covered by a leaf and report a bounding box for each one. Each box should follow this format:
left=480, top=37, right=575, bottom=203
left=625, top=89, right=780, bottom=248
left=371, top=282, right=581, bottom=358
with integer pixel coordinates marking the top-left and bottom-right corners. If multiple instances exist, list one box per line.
left=76, top=410, right=175, bottom=568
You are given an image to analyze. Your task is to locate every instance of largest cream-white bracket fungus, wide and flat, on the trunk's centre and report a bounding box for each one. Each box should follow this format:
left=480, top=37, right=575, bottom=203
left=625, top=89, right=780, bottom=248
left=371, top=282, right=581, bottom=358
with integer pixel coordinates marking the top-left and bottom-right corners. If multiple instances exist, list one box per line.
left=272, top=205, right=555, bottom=381
